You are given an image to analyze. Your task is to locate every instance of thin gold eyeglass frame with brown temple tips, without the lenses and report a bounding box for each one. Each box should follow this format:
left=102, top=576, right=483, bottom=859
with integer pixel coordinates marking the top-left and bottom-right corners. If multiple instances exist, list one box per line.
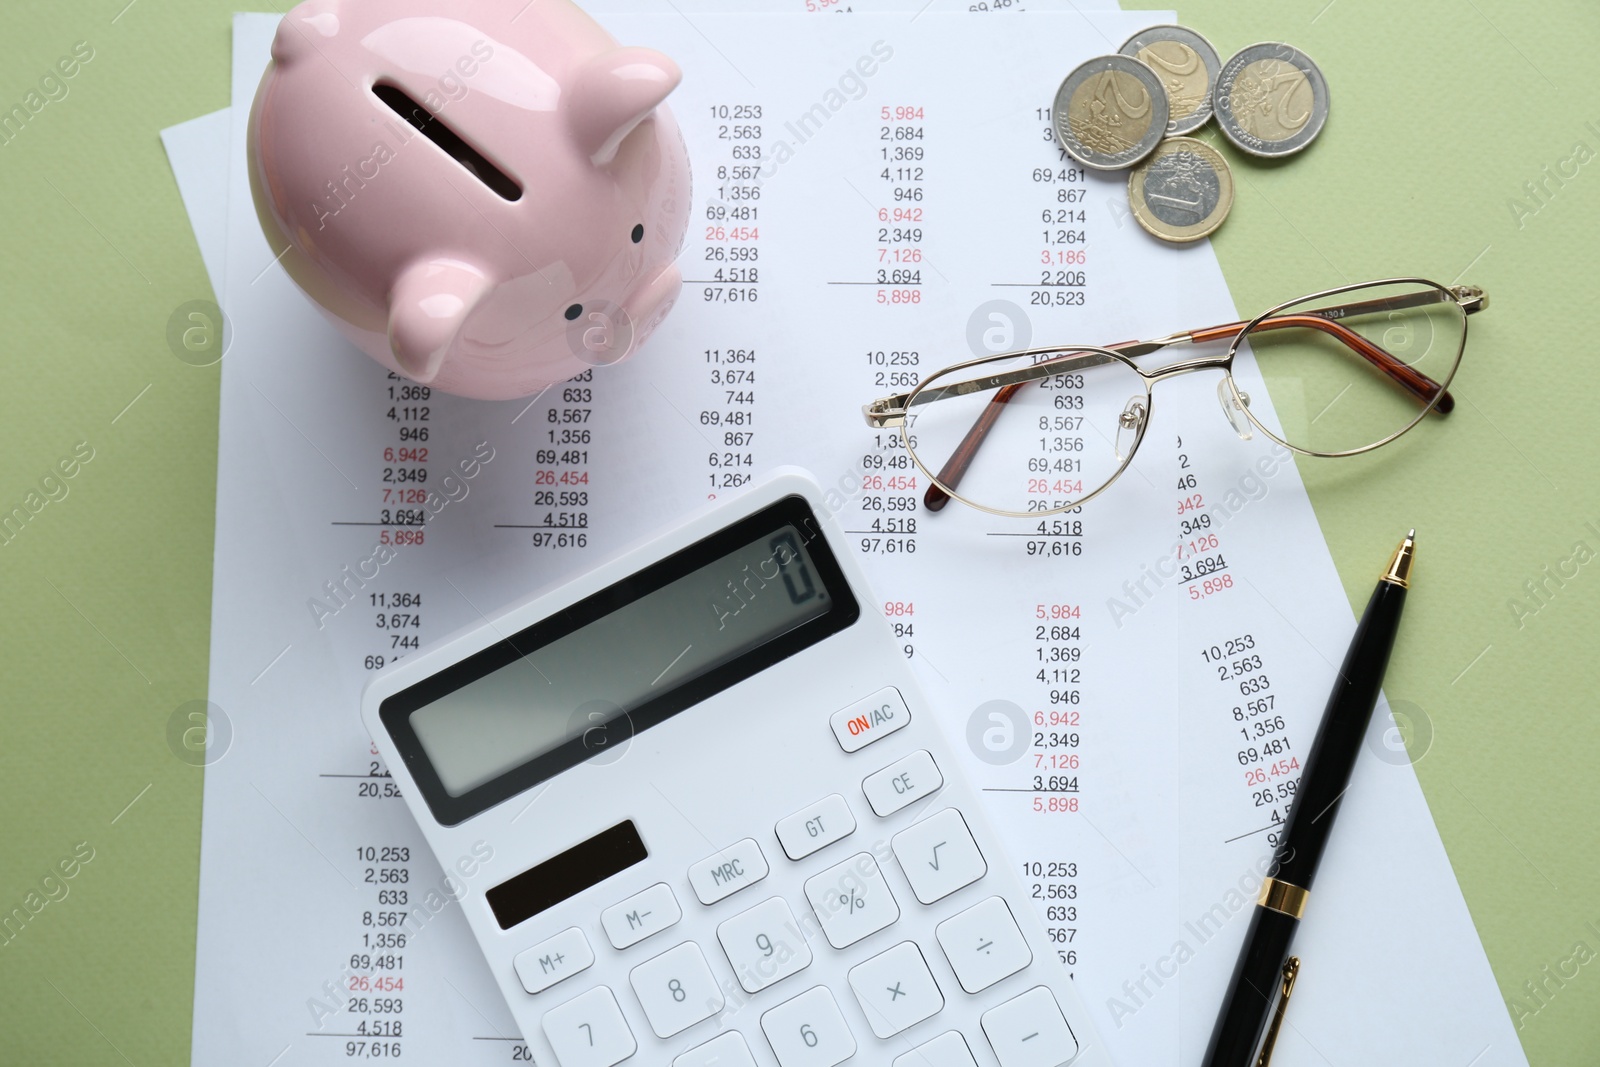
left=861, top=277, right=1490, bottom=518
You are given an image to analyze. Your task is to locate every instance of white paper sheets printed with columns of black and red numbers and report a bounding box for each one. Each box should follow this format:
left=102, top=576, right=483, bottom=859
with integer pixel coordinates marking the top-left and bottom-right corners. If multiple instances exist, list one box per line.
left=166, top=2, right=1526, bottom=1067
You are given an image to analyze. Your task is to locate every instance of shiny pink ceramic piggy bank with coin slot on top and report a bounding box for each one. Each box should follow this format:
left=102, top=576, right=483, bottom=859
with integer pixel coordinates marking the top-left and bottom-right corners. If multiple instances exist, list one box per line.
left=248, top=0, right=690, bottom=400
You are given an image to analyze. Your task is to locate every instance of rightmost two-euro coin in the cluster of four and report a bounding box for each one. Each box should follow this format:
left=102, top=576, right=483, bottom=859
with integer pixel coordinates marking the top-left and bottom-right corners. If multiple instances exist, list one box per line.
left=1213, top=42, right=1328, bottom=158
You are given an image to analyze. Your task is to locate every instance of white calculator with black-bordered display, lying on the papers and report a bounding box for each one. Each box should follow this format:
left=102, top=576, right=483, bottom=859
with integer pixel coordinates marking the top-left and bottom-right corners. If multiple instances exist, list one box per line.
left=362, top=472, right=1109, bottom=1067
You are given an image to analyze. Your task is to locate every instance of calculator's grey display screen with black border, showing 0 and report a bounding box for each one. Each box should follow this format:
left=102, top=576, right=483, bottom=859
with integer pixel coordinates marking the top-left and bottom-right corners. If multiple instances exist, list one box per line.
left=384, top=501, right=858, bottom=821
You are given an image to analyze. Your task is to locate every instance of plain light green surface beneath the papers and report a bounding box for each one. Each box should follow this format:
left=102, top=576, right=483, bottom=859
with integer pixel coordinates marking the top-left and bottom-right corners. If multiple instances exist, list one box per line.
left=0, top=0, right=1600, bottom=1067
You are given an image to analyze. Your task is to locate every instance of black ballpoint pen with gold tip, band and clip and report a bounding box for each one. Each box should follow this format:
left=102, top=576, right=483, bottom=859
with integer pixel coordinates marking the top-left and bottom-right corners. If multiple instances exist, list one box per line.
left=1202, top=530, right=1416, bottom=1067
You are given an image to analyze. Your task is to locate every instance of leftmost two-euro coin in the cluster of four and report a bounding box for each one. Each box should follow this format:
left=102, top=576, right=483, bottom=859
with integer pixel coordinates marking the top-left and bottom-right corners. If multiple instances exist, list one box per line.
left=1051, top=56, right=1166, bottom=171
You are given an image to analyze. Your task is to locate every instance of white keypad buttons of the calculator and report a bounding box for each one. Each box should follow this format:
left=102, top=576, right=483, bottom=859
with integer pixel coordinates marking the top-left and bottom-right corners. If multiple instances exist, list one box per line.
left=514, top=688, right=1078, bottom=1067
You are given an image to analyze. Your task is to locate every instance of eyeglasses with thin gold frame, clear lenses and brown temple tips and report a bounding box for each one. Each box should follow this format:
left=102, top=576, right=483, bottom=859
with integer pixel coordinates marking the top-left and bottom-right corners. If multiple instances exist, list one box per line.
left=862, top=278, right=1488, bottom=517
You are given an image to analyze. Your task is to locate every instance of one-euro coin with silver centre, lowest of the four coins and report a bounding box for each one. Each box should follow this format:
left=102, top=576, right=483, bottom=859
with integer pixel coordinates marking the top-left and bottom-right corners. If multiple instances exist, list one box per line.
left=1128, top=138, right=1234, bottom=245
